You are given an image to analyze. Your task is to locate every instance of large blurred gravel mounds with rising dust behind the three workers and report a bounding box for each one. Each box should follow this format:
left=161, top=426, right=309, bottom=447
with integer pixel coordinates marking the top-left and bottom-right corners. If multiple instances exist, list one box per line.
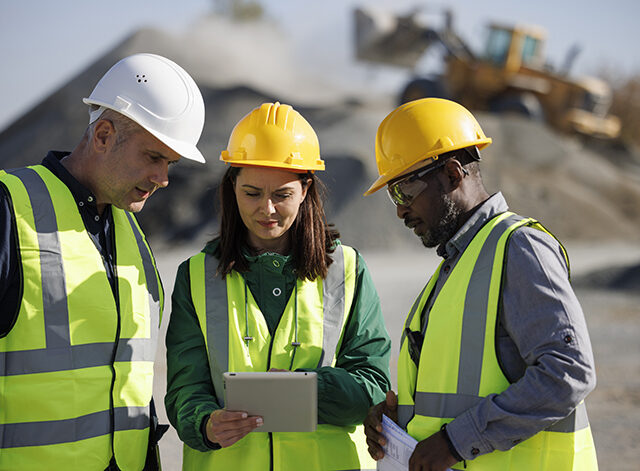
left=0, top=20, right=640, bottom=250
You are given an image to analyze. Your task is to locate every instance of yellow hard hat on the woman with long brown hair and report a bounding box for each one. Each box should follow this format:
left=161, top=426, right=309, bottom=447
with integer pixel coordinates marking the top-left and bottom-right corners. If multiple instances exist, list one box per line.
left=220, top=102, right=324, bottom=172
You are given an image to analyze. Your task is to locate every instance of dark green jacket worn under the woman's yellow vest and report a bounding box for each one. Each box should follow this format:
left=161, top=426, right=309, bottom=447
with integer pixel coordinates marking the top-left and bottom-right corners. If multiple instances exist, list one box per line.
left=165, top=241, right=391, bottom=451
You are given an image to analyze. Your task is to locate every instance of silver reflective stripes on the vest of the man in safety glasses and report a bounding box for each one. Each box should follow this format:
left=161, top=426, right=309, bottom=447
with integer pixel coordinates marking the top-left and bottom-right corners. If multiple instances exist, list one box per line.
left=410, top=214, right=589, bottom=433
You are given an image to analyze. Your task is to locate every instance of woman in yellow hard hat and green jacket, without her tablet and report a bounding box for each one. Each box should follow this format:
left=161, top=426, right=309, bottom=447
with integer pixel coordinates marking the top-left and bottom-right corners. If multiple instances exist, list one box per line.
left=165, top=103, right=390, bottom=471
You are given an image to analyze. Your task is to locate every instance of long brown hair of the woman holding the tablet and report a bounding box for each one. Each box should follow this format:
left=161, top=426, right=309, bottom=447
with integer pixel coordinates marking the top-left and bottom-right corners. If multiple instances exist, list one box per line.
left=214, top=167, right=340, bottom=280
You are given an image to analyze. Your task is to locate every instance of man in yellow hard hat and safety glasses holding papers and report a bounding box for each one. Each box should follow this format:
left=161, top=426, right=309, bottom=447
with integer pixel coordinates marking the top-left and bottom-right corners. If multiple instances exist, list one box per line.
left=365, top=98, right=597, bottom=471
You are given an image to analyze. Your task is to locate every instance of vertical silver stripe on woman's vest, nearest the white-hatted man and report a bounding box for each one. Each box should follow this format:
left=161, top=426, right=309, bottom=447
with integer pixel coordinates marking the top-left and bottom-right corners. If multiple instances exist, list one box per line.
left=204, top=254, right=229, bottom=407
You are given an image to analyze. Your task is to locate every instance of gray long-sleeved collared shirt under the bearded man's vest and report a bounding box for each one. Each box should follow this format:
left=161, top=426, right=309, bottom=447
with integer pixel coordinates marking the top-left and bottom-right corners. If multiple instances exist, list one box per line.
left=423, top=193, right=596, bottom=460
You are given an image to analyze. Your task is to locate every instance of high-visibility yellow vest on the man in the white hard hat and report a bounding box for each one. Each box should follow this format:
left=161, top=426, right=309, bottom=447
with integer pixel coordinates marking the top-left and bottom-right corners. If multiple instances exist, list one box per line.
left=0, top=165, right=164, bottom=471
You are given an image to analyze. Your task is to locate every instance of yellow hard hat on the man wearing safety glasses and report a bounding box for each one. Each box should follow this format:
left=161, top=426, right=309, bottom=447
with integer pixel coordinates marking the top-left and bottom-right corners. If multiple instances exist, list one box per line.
left=364, top=98, right=491, bottom=196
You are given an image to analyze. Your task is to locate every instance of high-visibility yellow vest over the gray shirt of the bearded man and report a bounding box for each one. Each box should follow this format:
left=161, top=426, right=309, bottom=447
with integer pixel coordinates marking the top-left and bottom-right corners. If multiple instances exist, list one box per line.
left=398, top=212, right=598, bottom=471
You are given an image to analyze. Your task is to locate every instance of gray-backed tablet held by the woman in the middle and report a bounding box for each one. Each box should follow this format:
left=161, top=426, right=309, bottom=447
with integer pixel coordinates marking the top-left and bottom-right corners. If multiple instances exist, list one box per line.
left=223, top=371, right=318, bottom=432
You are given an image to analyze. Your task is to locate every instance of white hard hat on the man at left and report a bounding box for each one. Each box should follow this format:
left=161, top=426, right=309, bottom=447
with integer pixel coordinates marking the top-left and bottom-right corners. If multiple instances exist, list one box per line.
left=82, top=54, right=205, bottom=163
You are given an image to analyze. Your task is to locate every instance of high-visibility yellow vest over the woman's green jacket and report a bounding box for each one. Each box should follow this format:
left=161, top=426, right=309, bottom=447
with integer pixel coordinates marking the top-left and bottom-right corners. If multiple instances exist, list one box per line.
left=183, top=245, right=376, bottom=471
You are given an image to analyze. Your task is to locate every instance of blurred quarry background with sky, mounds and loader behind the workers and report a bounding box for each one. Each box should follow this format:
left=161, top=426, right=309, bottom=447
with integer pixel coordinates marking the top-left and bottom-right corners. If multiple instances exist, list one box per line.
left=0, top=0, right=640, bottom=470
